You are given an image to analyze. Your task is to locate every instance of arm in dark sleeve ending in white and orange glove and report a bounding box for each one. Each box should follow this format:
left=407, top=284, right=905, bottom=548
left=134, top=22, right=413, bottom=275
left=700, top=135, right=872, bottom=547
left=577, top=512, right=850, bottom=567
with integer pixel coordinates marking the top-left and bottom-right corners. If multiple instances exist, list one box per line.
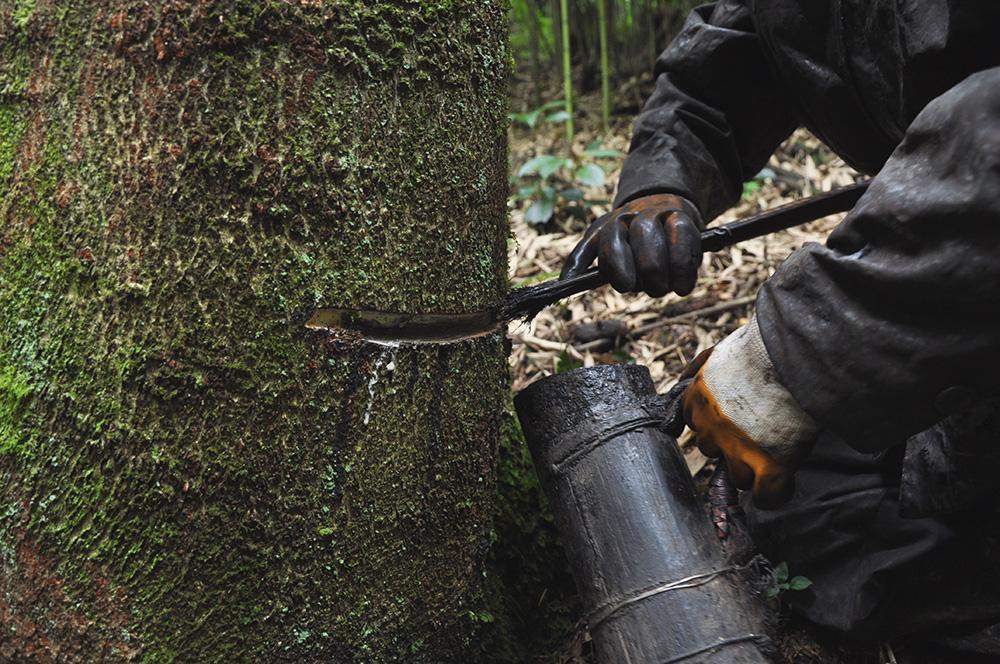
left=684, top=68, right=1000, bottom=507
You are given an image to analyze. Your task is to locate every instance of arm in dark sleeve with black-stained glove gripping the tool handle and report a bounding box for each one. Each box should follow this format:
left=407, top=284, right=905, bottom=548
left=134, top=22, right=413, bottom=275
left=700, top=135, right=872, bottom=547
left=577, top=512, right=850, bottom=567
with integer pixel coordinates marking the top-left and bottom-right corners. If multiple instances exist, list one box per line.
left=562, top=0, right=796, bottom=296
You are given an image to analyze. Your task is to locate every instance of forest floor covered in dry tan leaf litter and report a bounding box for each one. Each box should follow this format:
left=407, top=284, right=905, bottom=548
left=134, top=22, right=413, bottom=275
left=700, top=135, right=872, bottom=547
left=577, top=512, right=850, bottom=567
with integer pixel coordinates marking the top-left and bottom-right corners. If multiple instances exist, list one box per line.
left=509, top=81, right=964, bottom=664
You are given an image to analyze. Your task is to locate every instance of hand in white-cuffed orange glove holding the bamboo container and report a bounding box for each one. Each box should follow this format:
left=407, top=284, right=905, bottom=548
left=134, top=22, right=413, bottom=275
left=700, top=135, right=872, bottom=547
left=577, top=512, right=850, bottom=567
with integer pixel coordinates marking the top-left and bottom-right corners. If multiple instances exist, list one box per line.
left=682, top=318, right=819, bottom=509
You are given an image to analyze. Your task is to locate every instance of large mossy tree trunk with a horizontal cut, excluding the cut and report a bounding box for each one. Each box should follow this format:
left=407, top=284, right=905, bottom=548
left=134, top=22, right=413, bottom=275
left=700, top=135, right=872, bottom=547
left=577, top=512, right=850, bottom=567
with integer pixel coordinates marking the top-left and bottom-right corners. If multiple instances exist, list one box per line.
left=0, top=0, right=509, bottom=662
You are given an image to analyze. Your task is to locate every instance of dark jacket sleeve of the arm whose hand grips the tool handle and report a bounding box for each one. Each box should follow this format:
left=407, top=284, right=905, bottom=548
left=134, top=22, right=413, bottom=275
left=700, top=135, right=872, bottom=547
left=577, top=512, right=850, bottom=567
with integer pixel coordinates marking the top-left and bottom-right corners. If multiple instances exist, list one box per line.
left=615, top=0, right=797, bottom=221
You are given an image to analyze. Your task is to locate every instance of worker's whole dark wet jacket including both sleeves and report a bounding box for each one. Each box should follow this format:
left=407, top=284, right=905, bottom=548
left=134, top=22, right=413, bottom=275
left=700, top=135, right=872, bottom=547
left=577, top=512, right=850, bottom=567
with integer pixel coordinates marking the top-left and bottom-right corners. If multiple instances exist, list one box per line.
left=618, top=0, right=1000, bottom=512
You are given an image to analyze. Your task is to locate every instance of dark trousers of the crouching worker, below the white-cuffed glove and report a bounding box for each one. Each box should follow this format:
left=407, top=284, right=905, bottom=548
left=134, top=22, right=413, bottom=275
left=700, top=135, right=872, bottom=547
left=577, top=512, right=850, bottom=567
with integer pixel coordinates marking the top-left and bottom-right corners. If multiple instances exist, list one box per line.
left=744, top=435, right=1000, bottom=661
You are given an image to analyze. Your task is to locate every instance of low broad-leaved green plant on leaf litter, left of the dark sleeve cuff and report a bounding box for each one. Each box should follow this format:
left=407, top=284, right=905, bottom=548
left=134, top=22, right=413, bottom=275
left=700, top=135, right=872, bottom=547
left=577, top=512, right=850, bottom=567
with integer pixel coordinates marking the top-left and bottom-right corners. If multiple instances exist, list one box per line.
left=512, top=142, right=624, bottom=225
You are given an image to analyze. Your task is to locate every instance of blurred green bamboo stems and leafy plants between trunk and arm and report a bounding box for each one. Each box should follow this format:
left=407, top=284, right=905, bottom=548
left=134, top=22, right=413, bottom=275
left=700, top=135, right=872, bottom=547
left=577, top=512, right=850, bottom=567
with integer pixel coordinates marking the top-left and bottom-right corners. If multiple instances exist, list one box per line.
left=510, top=0, right=697, bottom=226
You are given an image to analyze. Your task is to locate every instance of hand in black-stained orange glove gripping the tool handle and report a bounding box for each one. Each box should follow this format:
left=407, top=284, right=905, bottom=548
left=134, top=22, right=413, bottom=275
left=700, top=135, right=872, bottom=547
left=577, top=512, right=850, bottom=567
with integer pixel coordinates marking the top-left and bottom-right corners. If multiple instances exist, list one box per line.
left=560, top=194, right=703, bottom=297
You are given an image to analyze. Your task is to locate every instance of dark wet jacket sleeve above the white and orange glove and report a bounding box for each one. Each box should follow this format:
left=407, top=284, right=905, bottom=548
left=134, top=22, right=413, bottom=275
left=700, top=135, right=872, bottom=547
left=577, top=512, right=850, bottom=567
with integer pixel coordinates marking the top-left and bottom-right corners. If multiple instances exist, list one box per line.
left=757, top=68, right=1000, bottom=451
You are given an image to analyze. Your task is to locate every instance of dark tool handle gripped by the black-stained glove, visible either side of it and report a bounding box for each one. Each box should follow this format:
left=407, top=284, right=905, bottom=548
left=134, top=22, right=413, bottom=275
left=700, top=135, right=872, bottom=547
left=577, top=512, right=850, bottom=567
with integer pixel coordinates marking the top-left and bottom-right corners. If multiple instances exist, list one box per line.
left=503, top=181, right=868, bottom=319
